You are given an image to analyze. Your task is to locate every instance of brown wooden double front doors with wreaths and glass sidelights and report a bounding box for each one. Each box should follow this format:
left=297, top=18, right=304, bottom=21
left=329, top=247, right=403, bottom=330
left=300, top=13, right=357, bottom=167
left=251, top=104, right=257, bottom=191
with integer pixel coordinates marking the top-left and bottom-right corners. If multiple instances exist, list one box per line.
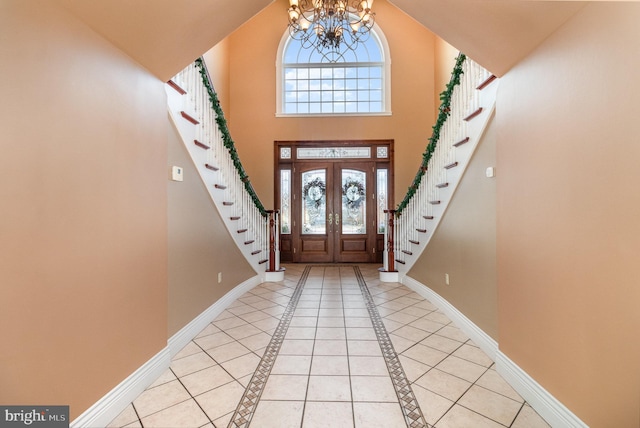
left=277, top=143, right=390, bottom=263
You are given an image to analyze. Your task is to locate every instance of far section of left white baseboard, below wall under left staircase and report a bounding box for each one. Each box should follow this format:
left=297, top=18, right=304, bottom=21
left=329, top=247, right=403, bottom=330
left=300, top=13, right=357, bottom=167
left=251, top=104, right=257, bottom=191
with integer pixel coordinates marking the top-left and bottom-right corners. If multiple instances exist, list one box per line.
left=167, top=275, right=262, bottom=358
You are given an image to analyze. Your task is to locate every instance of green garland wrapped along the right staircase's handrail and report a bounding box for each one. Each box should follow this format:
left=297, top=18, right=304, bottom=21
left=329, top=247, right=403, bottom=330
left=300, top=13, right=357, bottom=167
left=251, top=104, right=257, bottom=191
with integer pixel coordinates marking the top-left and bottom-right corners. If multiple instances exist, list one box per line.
left=396, top=53, right=466, bottom=217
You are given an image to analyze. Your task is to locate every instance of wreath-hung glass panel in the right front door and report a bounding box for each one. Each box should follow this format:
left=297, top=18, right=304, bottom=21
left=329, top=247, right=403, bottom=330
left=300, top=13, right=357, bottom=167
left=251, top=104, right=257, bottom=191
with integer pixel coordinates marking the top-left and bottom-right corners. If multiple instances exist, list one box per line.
left=341, top=169, right=367, bottom=234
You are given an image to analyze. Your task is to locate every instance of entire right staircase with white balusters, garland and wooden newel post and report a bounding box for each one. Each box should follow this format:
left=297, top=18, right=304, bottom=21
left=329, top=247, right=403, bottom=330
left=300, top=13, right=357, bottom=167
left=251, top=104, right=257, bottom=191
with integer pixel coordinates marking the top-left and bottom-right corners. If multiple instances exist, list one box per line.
left=380, top=54, right=498, bottom=282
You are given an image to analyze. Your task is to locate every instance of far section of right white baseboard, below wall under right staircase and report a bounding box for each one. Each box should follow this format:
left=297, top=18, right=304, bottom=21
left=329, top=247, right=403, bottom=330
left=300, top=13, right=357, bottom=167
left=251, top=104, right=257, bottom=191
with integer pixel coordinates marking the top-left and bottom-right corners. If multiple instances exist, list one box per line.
left=402, top=276, right=498, bottom=361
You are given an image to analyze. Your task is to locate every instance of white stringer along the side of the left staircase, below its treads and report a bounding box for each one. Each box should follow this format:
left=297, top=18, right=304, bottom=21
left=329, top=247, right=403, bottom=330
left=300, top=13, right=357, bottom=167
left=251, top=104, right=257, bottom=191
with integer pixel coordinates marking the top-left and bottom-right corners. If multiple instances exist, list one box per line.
left=165, top=85, right=266, bottom=280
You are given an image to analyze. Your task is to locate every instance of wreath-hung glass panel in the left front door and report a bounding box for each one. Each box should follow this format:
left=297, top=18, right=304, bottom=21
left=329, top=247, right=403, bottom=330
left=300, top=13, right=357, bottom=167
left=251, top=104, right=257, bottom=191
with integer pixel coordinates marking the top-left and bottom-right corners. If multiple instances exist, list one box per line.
left=301, top=169, right=327, bottom=234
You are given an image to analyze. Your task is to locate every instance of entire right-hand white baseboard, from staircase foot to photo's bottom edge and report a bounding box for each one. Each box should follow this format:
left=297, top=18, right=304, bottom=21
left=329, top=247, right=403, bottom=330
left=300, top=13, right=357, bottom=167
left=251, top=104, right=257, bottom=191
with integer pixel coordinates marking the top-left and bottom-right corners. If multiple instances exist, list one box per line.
left=402, top=276, right=588, bottom=428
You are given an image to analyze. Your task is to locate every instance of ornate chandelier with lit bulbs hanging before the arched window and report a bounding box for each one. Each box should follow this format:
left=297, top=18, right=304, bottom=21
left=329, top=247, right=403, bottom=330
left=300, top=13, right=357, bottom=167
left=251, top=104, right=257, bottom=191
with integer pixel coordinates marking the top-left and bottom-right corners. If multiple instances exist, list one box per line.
left=289, top=0, right=375, bottom=62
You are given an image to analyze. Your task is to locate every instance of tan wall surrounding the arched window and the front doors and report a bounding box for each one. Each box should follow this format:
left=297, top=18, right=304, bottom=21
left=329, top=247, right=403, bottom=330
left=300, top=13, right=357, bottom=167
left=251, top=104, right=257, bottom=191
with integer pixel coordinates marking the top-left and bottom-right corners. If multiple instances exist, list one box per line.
left=222, top=0, right=435, bottom=207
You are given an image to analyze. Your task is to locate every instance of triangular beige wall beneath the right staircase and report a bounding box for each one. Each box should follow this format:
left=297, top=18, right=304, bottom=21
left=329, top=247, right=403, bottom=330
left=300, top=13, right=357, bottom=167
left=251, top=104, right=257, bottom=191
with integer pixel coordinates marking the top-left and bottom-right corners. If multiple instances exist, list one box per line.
left=408, top=115, right=498, bottom=341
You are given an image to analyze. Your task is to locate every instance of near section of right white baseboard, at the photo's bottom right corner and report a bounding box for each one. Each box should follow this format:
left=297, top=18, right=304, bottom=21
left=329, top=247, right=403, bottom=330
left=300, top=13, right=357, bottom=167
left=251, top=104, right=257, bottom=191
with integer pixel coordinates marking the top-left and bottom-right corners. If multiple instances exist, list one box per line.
left=496, top=351, right=588, bottom=428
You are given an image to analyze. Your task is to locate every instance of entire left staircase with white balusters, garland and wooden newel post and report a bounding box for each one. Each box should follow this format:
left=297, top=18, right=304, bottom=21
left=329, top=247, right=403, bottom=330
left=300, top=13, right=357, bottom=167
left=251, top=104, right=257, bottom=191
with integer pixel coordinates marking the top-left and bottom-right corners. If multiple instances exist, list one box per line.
left=166, top=59, right=284, bottom=281
